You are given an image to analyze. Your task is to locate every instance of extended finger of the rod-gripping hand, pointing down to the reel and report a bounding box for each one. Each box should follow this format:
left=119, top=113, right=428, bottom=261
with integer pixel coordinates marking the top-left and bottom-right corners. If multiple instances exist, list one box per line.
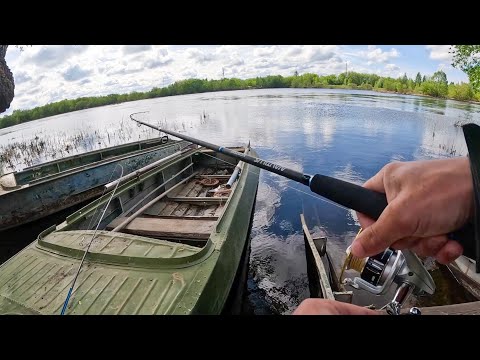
left=351, top=200, right=408, bottom=258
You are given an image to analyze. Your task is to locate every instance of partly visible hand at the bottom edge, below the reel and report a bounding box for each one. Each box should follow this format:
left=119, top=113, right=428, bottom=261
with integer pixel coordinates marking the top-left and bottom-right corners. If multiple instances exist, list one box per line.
left=292, top=299, right=379, bottom=315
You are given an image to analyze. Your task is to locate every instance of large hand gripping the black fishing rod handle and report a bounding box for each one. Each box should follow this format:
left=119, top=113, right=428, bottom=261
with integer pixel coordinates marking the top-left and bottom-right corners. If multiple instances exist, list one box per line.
left=351, top=157, right=474, bottom=264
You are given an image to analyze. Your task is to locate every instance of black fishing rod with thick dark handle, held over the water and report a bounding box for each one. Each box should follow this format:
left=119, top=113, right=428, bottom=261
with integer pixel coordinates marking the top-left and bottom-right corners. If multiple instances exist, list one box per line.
left=130, top=113, right=476, bottom=259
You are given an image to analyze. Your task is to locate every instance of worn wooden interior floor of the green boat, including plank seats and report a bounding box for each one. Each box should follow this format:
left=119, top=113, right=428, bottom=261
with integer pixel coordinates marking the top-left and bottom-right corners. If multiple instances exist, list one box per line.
left=106, top=167, right=234, bottom=247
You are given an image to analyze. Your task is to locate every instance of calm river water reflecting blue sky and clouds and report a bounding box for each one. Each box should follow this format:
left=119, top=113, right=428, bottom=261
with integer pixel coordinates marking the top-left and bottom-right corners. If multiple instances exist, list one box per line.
left=0, top=89, right=480, bottom=314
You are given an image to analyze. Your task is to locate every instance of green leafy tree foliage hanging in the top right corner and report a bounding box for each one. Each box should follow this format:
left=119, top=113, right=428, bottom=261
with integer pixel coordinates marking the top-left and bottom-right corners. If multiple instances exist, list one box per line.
left=451, top=45, right=480, bottom=91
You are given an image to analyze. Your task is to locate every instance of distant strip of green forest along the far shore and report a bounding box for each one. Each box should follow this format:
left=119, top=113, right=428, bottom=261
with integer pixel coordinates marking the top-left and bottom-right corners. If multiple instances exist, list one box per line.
left=0, top=71, right=480, bottom=128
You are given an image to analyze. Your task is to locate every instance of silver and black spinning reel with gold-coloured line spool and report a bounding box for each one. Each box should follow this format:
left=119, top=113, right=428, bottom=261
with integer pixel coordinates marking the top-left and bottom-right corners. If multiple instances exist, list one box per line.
left=340, top=232, right=435, bottom=315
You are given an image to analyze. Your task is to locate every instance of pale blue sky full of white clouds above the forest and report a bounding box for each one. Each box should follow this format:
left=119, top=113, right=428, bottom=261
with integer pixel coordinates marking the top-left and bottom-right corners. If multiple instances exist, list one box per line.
left=2, top=45, right=468, bottom=115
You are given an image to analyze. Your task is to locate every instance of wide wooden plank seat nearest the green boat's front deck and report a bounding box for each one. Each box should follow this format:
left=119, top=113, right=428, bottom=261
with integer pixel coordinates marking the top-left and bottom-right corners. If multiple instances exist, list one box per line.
left=106, top=217, right=217, bottom=241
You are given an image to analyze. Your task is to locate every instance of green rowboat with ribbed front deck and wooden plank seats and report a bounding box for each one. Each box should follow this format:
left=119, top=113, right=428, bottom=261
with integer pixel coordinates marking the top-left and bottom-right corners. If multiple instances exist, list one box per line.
left=0, top=143, right=259, bottom=315
